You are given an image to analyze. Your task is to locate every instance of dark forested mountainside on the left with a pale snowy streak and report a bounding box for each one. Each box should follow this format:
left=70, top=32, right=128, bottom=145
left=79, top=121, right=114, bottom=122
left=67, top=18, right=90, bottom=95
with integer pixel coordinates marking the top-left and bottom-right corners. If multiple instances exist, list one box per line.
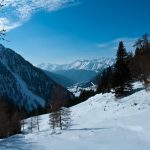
left=0, top=45, right=73, bottom=111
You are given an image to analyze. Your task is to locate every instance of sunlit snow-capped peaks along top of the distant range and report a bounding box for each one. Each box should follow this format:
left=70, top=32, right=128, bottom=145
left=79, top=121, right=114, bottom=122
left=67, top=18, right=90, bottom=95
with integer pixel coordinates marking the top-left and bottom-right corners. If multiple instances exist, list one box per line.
left=37, top=58, right=114, bottom=72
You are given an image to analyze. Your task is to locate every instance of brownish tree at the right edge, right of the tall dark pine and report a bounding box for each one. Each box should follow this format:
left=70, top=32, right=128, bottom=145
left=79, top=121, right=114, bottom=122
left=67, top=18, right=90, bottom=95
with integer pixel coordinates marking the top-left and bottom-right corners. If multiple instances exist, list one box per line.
left=134, top=34, right=150, bottom=90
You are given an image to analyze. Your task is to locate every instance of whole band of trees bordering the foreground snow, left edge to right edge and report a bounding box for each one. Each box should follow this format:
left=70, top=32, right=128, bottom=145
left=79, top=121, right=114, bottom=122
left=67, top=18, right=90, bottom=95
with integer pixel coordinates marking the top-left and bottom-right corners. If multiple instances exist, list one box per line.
left=0, top=34, right=150, bottom=138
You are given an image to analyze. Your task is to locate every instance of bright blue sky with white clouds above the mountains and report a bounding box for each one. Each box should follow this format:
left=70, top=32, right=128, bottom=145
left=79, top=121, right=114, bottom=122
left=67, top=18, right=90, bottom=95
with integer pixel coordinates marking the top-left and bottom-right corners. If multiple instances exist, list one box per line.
left=0, top=0, right=150, bottom=65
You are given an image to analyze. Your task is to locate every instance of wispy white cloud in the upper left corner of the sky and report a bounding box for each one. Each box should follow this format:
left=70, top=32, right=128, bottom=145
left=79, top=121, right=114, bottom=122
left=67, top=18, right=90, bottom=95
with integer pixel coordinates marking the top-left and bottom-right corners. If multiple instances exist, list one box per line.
left=0, top=0, right=79, bottom=30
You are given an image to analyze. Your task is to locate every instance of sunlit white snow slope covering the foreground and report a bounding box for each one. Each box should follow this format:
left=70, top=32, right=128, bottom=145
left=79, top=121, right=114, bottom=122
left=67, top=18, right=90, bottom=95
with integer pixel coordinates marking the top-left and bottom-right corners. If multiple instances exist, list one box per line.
left=0, top=83, right=150, bottom=150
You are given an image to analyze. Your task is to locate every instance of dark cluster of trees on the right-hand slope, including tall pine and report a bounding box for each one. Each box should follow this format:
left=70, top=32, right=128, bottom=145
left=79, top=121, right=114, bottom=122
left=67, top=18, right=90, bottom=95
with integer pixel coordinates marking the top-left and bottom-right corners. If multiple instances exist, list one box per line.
left=96, top=34, right=150, bottom=98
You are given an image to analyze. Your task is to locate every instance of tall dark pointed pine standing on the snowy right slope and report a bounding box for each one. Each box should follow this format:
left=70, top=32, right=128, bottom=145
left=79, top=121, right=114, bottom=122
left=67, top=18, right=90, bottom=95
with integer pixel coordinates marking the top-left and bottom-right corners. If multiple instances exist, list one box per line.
left=113, top=42, right=132, bottom=97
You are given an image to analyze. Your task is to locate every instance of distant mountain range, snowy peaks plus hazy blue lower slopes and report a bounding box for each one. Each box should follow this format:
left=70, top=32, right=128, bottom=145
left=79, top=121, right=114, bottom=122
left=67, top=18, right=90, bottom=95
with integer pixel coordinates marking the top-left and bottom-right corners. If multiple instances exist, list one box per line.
left=37, top=58, right=114, bottom=87
